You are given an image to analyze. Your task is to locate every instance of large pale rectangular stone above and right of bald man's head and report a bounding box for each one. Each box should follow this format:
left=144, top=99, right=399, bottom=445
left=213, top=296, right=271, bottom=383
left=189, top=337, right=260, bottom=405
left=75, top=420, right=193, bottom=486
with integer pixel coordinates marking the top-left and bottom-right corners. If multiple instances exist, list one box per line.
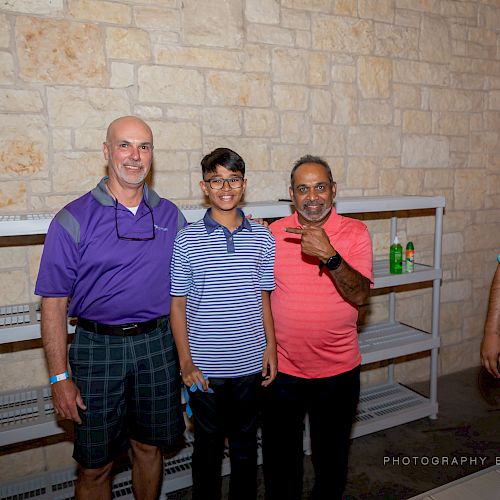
left=138, top=66, right=203, bottom=104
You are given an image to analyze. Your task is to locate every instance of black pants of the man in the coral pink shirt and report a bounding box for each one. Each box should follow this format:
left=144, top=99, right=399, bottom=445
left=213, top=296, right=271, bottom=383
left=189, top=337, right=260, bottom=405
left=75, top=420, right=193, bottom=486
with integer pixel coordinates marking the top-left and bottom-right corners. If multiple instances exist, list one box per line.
left=262, top=366, right=360, bottom=500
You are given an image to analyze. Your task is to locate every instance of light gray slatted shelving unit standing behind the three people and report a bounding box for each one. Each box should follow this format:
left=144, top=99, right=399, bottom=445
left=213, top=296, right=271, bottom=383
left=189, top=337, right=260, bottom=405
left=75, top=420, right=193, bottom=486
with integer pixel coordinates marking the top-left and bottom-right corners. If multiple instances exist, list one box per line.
left=0, top=196, right=445, bottom=498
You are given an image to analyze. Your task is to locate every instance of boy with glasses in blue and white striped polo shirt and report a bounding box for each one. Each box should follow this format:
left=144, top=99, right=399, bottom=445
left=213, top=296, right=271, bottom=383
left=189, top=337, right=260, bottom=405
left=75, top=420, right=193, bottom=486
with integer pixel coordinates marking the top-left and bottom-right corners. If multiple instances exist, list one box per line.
left=170, top=148, right=277, bottom=500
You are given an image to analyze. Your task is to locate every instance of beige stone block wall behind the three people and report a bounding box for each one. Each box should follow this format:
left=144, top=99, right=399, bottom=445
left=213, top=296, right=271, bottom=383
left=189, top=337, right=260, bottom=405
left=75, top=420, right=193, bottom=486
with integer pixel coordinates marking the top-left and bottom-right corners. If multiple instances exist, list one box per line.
left=0, top=0, right=500, bottom=484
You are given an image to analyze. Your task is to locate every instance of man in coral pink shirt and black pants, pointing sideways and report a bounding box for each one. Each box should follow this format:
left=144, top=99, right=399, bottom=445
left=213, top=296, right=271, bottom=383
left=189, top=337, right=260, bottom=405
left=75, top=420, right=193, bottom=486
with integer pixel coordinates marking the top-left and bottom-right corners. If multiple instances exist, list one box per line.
left=263, top=155, right=372, bottom=500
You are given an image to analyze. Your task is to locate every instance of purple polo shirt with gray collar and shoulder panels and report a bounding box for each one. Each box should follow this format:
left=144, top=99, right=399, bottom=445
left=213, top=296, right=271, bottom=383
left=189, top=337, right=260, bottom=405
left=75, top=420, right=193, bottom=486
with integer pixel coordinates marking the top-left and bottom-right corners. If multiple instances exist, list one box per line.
left=35, top=177, right=186, bottom=325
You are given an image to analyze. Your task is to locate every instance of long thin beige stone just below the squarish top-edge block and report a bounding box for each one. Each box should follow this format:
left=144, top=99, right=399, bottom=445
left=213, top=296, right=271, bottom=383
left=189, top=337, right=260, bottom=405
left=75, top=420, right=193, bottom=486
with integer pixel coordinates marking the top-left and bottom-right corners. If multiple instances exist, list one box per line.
left=155, top=45, right=242, bottom=70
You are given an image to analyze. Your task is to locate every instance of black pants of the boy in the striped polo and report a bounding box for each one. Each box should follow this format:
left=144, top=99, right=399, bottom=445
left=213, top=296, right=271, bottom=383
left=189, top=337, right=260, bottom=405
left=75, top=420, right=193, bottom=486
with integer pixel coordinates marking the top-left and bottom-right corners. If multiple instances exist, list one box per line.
left=190, top=372, right=262, bottom=500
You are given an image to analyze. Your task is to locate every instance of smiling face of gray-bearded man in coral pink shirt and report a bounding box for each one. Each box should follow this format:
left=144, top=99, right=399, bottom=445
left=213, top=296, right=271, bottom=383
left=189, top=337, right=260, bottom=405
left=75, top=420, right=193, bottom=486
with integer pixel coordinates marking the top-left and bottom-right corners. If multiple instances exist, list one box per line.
left=290, top=163, right=337, bottom=226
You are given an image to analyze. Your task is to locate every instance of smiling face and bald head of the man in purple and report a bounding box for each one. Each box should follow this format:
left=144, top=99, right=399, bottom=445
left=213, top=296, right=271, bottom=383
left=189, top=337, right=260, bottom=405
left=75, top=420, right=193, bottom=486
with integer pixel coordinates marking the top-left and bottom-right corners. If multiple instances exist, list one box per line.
left=103, top=116, right=153, bottom=188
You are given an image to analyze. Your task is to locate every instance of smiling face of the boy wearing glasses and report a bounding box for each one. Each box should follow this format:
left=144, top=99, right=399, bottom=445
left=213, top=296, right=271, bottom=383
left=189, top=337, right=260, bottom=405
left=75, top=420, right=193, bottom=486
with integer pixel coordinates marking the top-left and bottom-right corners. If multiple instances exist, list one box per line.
left=200, top=165, right=247, bottom=212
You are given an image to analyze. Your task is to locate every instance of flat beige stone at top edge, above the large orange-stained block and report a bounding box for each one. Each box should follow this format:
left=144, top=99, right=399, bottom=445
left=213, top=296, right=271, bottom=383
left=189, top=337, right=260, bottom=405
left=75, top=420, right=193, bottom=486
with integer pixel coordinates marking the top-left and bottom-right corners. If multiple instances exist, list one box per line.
left=68, top=0, right=132, bottom=25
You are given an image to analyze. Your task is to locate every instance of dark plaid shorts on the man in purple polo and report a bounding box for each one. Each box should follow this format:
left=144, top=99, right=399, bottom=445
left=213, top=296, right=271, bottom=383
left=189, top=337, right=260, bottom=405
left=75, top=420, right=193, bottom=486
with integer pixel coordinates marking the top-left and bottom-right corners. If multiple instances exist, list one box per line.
left=69, top=318, right=184, bottom=469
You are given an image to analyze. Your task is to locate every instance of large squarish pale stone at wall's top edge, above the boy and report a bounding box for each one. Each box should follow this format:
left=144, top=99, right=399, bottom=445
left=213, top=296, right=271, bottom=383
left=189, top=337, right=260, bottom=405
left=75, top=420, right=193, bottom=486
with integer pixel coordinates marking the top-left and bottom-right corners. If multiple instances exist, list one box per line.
left=182, top=0, right=243, bottom=49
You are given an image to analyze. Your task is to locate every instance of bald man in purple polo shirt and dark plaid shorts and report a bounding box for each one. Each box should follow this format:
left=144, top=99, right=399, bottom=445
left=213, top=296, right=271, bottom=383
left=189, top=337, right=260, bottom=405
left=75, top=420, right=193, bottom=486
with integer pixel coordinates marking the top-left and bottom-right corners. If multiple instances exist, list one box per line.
left=35, top=116, right=186, bottom=500
